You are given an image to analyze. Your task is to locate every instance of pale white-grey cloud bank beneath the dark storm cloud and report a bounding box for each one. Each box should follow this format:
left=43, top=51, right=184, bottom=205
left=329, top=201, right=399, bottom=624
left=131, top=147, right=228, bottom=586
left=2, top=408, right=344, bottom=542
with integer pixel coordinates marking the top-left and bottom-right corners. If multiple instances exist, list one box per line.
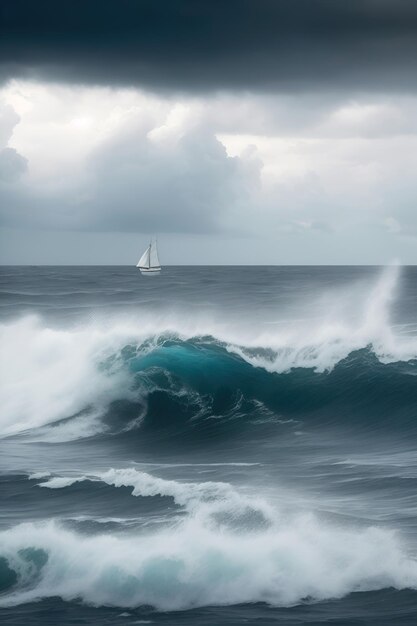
left=0, top=81, right=417, bottom=262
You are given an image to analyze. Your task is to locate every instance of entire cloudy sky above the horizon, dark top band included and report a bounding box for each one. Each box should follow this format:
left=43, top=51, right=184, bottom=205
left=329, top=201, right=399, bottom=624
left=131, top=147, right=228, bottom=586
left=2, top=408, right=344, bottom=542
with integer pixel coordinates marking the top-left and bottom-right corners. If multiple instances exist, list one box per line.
left=0, top=0, right=417, bottom=265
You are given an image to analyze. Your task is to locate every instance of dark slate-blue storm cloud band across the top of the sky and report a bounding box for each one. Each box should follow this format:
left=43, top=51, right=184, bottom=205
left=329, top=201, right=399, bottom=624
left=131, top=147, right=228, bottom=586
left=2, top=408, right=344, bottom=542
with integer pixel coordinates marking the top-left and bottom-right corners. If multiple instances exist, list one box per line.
left=0, top=0, right=417, bottom=90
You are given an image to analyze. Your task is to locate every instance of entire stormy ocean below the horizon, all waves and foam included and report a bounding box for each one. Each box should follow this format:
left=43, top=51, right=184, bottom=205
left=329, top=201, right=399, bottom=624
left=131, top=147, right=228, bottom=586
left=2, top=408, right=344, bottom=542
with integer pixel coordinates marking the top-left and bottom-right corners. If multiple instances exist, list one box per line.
left=0, top=266, right=417, bottom=626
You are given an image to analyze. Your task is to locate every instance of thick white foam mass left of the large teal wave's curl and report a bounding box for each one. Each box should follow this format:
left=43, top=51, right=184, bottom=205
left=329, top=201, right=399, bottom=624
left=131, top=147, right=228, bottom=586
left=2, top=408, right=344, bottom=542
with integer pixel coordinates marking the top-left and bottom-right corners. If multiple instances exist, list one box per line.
left=0, top=316, right=136, bottom=438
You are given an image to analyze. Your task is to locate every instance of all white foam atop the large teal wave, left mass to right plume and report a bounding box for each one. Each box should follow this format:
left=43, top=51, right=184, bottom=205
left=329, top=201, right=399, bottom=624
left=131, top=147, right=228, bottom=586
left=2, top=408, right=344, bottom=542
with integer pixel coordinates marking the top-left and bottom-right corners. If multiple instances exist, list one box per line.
left=0, top=266, right=417, bottom=434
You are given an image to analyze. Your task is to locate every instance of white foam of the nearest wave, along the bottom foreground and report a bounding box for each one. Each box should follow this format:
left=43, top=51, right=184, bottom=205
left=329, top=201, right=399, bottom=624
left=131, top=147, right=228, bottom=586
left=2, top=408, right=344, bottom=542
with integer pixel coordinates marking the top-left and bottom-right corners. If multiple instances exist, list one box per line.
left=0, top=516, right=417, bottom=610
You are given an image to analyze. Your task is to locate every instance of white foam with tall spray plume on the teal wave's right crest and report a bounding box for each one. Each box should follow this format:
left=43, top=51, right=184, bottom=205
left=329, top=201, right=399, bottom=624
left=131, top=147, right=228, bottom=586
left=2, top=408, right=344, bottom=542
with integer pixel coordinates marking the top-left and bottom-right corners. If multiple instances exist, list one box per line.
left=227, top=265, right=417, bottom=373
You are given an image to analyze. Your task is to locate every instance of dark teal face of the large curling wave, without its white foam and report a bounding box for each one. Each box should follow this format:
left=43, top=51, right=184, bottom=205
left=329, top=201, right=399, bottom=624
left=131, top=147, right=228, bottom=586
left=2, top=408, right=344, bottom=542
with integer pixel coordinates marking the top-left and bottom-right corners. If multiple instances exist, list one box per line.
left=95, top=339, right=417, bottom=442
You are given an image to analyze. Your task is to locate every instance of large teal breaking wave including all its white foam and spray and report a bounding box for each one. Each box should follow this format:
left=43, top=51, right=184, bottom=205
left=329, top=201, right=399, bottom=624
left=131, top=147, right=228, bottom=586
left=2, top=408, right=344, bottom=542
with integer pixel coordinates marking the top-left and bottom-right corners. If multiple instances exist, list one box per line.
left=0, top=267, right=417, bottom=441
